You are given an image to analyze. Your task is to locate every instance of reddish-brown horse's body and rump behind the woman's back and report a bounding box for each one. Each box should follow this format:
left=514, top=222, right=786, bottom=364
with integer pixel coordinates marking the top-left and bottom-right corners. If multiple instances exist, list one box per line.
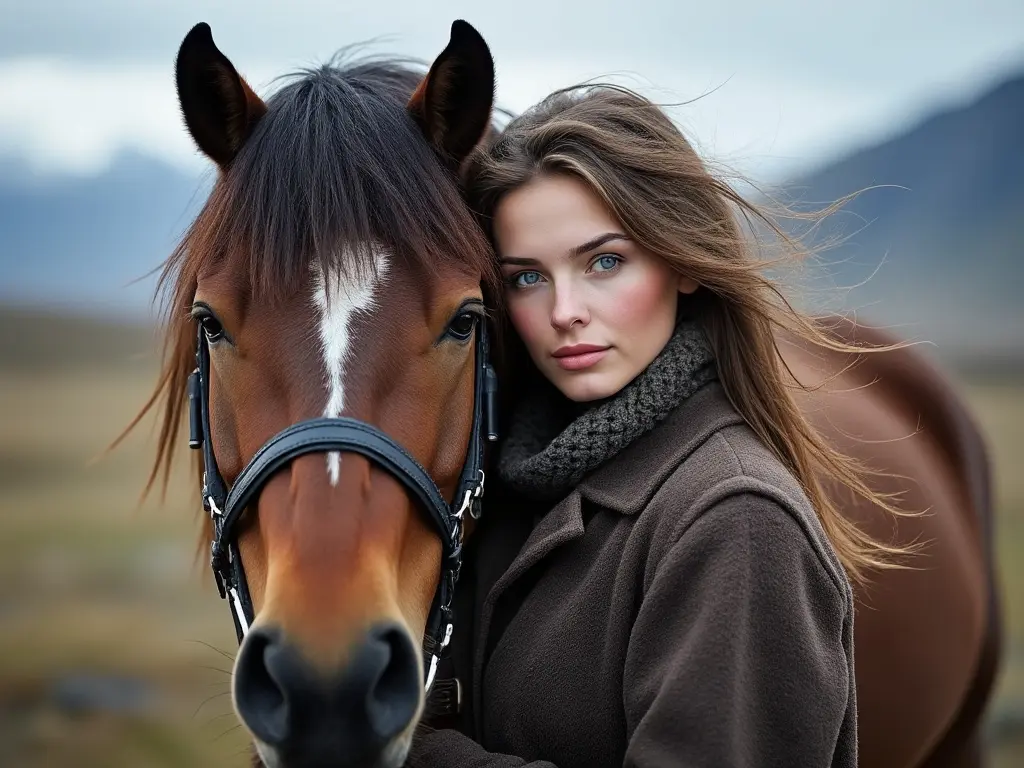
left=780, top=319, right=999, bottom=768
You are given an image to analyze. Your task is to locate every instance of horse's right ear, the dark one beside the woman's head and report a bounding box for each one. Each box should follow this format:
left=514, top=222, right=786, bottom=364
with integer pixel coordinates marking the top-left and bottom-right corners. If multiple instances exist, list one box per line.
left=408, top=19, right=495, bottom=169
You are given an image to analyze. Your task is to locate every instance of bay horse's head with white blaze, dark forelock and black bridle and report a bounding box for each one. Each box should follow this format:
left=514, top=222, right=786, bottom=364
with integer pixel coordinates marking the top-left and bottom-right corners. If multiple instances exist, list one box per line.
left=134, top=20, right=500, bottom=768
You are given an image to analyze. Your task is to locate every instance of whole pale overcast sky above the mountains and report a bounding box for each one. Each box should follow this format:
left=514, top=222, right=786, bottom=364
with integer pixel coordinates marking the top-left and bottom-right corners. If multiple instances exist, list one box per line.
left=0, top=0, right=1024, bottom=179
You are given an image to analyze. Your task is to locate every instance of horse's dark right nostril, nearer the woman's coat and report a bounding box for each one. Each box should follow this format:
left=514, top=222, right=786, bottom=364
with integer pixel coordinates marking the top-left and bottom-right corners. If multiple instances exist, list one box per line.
left=366, top=625, right=421, bottom=740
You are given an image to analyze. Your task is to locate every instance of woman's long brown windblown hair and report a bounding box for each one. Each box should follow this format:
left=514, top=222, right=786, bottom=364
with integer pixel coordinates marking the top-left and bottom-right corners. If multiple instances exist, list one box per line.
left=467, top=85, right=908, bottom=581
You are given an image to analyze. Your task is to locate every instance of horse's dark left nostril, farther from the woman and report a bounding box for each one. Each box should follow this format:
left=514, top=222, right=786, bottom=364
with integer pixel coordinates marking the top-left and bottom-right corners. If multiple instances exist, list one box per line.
left=234, top=629, right=290, bottom=746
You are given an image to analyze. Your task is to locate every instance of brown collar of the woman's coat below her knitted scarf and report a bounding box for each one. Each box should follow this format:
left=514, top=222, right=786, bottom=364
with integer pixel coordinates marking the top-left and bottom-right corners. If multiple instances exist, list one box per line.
left=578, top=381, right=743, bottom=515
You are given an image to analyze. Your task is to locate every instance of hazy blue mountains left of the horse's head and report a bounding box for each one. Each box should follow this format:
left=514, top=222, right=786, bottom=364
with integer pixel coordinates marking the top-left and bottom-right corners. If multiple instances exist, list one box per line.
left=0, top=153, right=209, bottom=318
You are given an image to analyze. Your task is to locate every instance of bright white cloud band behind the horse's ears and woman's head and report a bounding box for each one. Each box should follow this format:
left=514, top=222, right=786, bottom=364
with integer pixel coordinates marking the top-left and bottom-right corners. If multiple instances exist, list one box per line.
left=0, top=53, right=958, bottom=184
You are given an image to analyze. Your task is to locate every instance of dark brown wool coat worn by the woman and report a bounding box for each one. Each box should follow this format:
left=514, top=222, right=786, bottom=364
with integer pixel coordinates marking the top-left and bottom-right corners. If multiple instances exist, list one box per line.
left=409, top=383, right=857, bottom=768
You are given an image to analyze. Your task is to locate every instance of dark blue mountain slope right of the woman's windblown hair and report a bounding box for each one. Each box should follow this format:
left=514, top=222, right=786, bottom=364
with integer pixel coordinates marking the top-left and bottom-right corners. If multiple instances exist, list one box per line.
left=785, top=74, right=1024, bottom=356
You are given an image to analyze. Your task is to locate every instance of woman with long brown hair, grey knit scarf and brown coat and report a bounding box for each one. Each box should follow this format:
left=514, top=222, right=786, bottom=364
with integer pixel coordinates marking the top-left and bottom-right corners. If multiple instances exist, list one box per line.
left=411, top=87, right=905, bottom=768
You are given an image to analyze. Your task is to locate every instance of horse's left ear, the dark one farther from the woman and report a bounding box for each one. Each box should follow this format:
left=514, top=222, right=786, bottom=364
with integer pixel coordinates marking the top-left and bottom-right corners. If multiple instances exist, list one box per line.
left=175, top=23, right=266, bottom=168
